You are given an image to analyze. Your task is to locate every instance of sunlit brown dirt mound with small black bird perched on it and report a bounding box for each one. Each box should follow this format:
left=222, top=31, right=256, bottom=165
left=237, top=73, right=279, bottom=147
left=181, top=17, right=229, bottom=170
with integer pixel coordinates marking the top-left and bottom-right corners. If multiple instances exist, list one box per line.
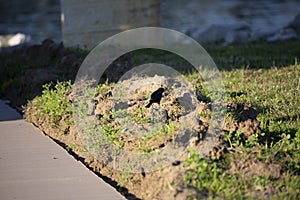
left=25, top=72, right=257, bottom=199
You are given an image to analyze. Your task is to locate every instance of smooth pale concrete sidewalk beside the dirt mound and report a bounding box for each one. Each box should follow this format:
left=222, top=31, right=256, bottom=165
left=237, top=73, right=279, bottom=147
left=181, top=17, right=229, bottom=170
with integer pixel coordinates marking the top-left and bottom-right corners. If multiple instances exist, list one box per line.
left=0, top=101, right=125, bottom=200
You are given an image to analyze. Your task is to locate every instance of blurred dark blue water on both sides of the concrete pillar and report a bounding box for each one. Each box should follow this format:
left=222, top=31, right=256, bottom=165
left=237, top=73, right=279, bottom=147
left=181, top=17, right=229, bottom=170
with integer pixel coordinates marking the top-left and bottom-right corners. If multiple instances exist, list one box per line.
left=0, top=0, right=300, bottom=46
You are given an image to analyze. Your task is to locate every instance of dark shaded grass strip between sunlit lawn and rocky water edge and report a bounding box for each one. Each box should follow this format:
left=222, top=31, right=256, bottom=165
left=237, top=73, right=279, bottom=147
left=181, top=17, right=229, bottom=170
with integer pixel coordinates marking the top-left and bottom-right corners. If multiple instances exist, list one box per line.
left=204, top=41, right=300, bottom=70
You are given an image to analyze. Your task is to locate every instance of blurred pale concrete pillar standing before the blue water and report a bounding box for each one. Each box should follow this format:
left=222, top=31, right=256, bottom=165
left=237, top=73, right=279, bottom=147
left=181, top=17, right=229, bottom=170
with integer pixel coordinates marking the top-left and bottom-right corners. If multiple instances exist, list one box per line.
left=61, top=0, right=160, bottom=49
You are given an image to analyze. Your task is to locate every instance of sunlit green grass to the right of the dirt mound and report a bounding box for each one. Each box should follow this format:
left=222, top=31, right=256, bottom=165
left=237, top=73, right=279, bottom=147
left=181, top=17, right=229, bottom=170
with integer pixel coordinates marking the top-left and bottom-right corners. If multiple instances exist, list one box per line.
left=186, top=63, right=300, bottom=199
